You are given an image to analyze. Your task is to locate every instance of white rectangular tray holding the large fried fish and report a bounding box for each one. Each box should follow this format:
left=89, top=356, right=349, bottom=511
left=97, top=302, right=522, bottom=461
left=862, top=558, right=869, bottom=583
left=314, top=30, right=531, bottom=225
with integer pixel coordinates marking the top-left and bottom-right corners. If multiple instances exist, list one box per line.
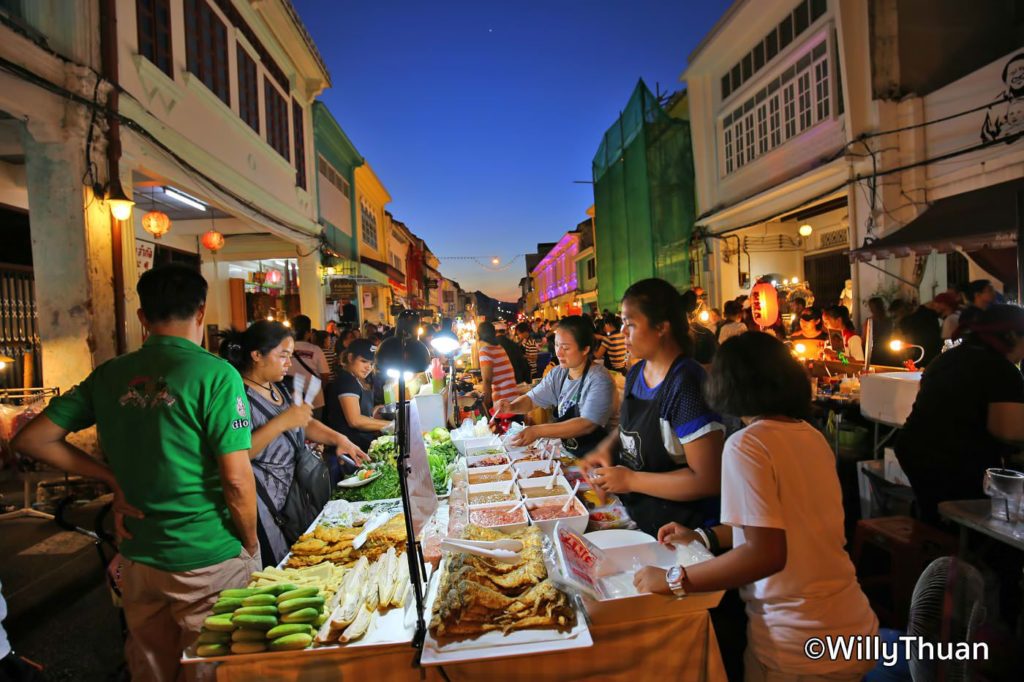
left=420, top=559, right=594, bottom=666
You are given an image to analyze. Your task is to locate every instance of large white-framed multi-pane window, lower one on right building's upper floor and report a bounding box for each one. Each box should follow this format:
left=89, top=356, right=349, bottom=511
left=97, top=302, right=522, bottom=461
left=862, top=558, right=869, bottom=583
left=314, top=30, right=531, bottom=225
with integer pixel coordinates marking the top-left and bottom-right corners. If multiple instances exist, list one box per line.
left=719, top=29, right=836, bottom=175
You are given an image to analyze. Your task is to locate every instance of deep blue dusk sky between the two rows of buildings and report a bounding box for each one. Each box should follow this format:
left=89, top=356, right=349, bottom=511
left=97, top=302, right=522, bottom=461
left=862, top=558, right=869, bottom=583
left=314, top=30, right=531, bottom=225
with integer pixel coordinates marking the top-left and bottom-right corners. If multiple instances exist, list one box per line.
left=293, top=0, right=729, bottom=300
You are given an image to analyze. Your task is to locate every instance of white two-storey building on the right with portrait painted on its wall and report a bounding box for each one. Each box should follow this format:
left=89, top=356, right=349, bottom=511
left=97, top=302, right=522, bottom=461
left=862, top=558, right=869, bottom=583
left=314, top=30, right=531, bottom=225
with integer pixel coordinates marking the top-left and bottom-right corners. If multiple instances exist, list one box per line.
left=682, top=0, right=1024, bottom=314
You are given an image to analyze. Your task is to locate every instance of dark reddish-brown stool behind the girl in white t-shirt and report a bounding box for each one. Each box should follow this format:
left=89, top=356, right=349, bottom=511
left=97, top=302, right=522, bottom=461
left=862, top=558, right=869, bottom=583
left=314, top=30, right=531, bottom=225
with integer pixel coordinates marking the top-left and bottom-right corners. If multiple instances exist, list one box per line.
left=851, top=516, right=956, bottom=628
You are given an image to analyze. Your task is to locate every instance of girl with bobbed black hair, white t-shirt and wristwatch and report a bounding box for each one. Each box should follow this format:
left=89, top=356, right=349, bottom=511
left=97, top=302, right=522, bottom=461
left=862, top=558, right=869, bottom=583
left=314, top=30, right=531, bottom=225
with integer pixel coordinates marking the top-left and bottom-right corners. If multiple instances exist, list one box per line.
left=634, top=333, right=879, bottom=682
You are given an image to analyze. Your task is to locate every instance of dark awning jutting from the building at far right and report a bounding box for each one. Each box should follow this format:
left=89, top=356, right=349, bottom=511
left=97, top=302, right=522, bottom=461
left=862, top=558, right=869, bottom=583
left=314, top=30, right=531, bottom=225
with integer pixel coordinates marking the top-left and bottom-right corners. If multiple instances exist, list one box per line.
left=850, top=179, right=1024, bottom=261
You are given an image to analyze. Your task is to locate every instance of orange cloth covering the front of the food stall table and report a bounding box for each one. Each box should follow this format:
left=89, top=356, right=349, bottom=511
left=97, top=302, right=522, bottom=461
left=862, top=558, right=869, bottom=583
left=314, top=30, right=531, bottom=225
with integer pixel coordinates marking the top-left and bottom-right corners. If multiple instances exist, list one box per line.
left=215, top=611, right=726, bottom=682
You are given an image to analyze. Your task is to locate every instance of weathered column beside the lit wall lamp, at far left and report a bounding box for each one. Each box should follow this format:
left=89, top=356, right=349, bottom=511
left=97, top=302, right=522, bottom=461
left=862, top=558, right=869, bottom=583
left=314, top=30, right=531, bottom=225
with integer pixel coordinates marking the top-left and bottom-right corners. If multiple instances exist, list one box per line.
left=24, top=127, right=116, bottom=390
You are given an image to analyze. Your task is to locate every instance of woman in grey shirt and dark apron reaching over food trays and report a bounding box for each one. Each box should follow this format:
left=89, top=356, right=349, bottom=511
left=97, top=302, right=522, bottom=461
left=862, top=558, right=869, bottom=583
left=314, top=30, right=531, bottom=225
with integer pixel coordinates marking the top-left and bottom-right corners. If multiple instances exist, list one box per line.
left=495, top=315, right=615, bottom=457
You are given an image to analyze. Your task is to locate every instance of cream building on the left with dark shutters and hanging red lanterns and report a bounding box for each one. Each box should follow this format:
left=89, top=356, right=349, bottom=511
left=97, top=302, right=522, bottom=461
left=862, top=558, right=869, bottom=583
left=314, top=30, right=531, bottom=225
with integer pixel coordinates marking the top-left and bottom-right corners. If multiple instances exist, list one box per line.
left=0, top=0, right=330, bottom=388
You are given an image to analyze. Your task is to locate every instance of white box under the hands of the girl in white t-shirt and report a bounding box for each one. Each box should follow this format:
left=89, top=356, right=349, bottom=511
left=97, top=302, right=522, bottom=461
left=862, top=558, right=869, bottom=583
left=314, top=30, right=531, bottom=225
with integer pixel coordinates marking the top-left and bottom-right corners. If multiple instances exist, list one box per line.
left=584, top=530, right=725, bottom=625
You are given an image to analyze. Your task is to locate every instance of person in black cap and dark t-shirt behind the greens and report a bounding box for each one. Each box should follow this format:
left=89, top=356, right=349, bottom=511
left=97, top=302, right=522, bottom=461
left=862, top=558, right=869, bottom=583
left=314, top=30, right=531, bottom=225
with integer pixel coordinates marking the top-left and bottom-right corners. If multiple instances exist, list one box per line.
left=325, top=339, right=390, bottom=451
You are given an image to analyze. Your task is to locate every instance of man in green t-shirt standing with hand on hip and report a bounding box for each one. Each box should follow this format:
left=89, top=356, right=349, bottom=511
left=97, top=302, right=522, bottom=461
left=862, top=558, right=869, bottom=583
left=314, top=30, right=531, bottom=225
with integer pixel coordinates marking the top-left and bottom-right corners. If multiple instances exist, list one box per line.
left=13, top=265, right=262, bottom=681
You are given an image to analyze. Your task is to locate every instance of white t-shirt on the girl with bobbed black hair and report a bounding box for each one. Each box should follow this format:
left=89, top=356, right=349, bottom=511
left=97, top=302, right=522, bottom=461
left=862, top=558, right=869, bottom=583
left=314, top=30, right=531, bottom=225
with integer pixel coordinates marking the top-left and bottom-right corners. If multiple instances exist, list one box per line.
left=722, top=420, right=879, bottom=675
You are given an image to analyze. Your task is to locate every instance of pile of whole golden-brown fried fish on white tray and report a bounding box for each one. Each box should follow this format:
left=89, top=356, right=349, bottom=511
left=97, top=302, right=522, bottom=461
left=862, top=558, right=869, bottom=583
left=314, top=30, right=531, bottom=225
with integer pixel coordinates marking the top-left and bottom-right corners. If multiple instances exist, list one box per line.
left=430, top=525, right=577, bottom=641
